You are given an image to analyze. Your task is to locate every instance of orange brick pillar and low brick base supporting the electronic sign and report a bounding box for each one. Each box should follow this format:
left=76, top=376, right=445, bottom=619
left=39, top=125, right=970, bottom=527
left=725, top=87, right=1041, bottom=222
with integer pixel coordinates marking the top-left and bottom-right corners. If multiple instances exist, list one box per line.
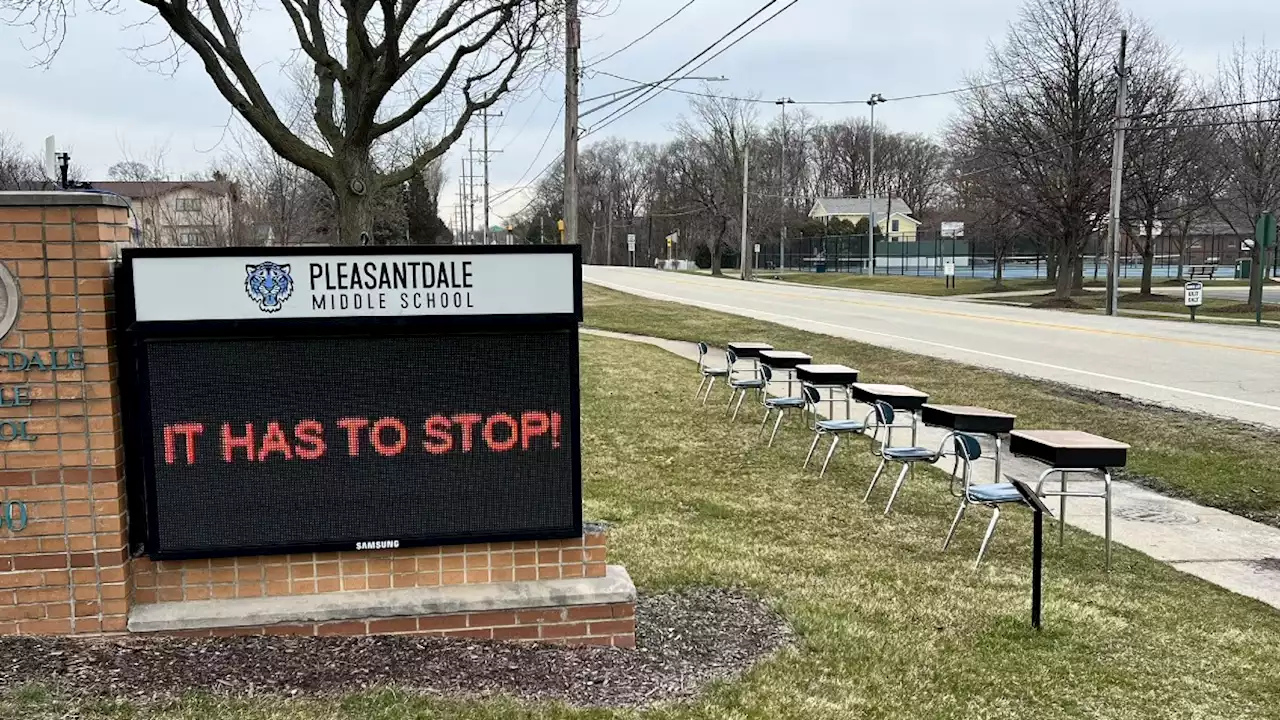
left=0, top=192, right=635, bottom=647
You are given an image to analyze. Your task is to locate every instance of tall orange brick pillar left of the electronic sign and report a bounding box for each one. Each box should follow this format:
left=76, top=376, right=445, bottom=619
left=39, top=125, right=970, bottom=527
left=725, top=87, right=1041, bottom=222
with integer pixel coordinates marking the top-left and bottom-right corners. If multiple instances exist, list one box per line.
left=0, top=192, right=131, bottom=634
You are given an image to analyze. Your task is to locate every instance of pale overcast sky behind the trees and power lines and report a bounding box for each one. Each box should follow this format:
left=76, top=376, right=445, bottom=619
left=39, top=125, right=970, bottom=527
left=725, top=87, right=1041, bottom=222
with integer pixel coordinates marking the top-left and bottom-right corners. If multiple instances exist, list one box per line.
left=0, top=0, right=1280, bottom=222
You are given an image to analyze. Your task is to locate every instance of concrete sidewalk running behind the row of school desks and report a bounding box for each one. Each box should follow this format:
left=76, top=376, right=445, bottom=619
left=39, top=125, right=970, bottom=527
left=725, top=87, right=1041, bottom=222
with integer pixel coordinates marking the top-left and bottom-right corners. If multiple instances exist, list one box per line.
left=582, top=328, right=1280, bottom=609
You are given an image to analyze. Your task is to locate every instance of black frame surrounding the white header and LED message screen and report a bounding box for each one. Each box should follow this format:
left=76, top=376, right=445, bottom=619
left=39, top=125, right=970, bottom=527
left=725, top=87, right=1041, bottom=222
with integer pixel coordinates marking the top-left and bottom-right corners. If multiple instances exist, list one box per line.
left=114, top=245, right=582, bottom=560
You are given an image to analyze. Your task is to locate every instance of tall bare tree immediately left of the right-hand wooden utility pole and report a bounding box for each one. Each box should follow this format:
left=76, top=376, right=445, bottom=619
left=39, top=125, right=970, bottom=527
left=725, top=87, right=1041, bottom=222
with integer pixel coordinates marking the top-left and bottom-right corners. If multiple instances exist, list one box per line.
left=951, top=0, right=1123, bottom=299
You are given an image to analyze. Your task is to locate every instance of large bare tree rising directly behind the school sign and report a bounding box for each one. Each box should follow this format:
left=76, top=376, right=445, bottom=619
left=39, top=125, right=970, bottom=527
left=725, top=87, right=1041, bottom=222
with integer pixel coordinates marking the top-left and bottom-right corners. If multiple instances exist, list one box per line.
left=0, top=0, right=563, bottom=243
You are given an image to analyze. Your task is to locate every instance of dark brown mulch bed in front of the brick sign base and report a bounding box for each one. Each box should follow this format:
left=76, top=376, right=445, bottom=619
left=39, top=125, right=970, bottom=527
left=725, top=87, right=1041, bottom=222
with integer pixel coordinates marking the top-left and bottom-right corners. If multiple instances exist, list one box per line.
left=0, top=588, right=792, bottom=707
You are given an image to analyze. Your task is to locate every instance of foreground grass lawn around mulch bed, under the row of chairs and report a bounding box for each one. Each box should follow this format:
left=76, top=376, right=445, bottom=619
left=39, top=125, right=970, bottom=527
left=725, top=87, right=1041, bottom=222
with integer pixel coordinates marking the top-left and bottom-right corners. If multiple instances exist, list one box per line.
left=10, top=333, right=1280, bottom=720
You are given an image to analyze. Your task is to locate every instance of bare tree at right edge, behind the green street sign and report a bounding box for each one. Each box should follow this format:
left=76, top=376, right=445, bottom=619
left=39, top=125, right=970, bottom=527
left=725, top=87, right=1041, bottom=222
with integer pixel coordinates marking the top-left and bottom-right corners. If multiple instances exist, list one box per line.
left=1210, top=44, right=1280, bottom=309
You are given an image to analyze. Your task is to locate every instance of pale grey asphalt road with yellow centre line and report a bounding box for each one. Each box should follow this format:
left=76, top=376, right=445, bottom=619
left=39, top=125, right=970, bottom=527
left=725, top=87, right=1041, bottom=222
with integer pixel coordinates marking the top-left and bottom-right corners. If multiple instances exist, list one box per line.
left=582, top=266, right=1280, bottom=428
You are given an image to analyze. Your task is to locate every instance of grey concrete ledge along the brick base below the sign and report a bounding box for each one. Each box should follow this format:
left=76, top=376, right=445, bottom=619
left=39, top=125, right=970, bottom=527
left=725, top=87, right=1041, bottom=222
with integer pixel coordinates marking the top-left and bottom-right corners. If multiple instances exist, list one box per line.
left=128, top=565, right=636, bottom=633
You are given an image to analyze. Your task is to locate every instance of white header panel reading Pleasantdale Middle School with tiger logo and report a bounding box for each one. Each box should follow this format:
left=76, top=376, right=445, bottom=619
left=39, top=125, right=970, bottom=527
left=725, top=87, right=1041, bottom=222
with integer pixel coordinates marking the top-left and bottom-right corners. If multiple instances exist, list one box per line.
left=133, top=251, right=575, bottom=323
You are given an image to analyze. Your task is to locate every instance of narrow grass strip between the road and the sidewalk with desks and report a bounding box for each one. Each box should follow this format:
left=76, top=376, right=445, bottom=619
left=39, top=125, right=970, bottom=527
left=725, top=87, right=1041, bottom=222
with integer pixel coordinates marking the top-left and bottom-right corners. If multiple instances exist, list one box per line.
left=586, top=286, right=1280, bottom=527
